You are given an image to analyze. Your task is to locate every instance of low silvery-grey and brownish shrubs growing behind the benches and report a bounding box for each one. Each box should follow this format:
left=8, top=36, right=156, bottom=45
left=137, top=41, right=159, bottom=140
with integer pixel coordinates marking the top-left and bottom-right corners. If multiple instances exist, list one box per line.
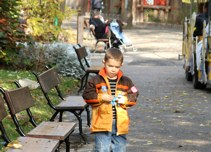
left=17, top=43, right=89, bottom=79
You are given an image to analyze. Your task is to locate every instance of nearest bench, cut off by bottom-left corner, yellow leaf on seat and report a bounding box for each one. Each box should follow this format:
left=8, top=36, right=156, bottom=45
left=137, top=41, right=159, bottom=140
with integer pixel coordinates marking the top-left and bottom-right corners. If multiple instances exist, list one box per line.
left=0, top=96, right=59, bottom=152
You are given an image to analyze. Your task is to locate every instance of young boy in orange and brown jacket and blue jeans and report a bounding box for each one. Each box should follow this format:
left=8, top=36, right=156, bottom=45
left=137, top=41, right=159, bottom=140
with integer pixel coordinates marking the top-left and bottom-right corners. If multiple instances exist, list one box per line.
left=83, top=48, right=138, bottom=152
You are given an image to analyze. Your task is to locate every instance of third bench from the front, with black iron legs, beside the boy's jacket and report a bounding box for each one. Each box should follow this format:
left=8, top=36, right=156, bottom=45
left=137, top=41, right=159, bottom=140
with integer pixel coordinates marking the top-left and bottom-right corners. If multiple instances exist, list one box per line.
left=34, top=67, right=90, bottom=142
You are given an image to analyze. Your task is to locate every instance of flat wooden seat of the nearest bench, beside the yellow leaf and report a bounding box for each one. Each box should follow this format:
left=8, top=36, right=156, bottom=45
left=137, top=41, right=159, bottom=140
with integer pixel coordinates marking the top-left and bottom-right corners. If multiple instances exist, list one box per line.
left=6, top=137, right=59, bottom=152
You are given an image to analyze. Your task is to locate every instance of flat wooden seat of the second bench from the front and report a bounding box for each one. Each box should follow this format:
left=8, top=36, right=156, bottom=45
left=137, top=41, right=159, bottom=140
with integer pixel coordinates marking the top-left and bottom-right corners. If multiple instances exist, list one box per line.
left=26, top=122, right=76, bottom=140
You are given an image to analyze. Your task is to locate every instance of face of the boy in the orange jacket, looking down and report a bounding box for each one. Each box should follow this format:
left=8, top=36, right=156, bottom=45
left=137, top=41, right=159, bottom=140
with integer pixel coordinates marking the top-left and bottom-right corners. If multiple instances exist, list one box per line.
left=103, top=59, right=122, bottom=79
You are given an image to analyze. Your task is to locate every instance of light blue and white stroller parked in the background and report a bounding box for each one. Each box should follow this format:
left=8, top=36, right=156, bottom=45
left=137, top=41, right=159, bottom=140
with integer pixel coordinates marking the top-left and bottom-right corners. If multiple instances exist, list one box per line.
left=109, top=19, right=135, bottom=52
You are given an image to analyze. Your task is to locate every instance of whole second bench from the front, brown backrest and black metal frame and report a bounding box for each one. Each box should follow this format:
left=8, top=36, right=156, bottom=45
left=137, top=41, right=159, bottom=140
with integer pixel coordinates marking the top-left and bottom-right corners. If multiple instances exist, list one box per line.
left=1, top=87, right=76, bottom=152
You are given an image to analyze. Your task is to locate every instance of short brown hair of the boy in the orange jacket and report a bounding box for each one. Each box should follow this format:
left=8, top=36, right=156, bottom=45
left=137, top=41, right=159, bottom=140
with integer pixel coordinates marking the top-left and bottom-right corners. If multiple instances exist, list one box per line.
left=104, top=48, right=123, bottom=63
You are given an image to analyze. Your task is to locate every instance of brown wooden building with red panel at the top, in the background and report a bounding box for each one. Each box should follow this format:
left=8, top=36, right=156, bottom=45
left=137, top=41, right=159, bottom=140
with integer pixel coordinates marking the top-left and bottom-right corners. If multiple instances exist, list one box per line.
left=66, top=0, right=198, bottom=25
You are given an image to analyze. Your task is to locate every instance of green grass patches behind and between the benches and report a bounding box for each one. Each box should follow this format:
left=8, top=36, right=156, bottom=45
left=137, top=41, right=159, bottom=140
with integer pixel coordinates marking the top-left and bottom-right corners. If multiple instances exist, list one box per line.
left=0, top=70, right=78, bottom=151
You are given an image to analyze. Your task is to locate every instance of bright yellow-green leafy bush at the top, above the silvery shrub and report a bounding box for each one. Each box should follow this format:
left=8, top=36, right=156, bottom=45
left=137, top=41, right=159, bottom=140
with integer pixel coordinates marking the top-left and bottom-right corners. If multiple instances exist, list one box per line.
left=21, top=0, right=75, bottom=42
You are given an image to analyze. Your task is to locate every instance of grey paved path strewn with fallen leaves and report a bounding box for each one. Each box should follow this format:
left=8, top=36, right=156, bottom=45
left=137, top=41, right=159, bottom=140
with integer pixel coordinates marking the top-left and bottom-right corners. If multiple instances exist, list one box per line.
left=61, top=22, right=211, bottom=152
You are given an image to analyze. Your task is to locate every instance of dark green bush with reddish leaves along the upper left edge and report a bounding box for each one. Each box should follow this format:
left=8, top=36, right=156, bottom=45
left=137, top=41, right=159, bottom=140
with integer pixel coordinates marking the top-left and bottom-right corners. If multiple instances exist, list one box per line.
left=0, top=0, right=26, bottom=66
